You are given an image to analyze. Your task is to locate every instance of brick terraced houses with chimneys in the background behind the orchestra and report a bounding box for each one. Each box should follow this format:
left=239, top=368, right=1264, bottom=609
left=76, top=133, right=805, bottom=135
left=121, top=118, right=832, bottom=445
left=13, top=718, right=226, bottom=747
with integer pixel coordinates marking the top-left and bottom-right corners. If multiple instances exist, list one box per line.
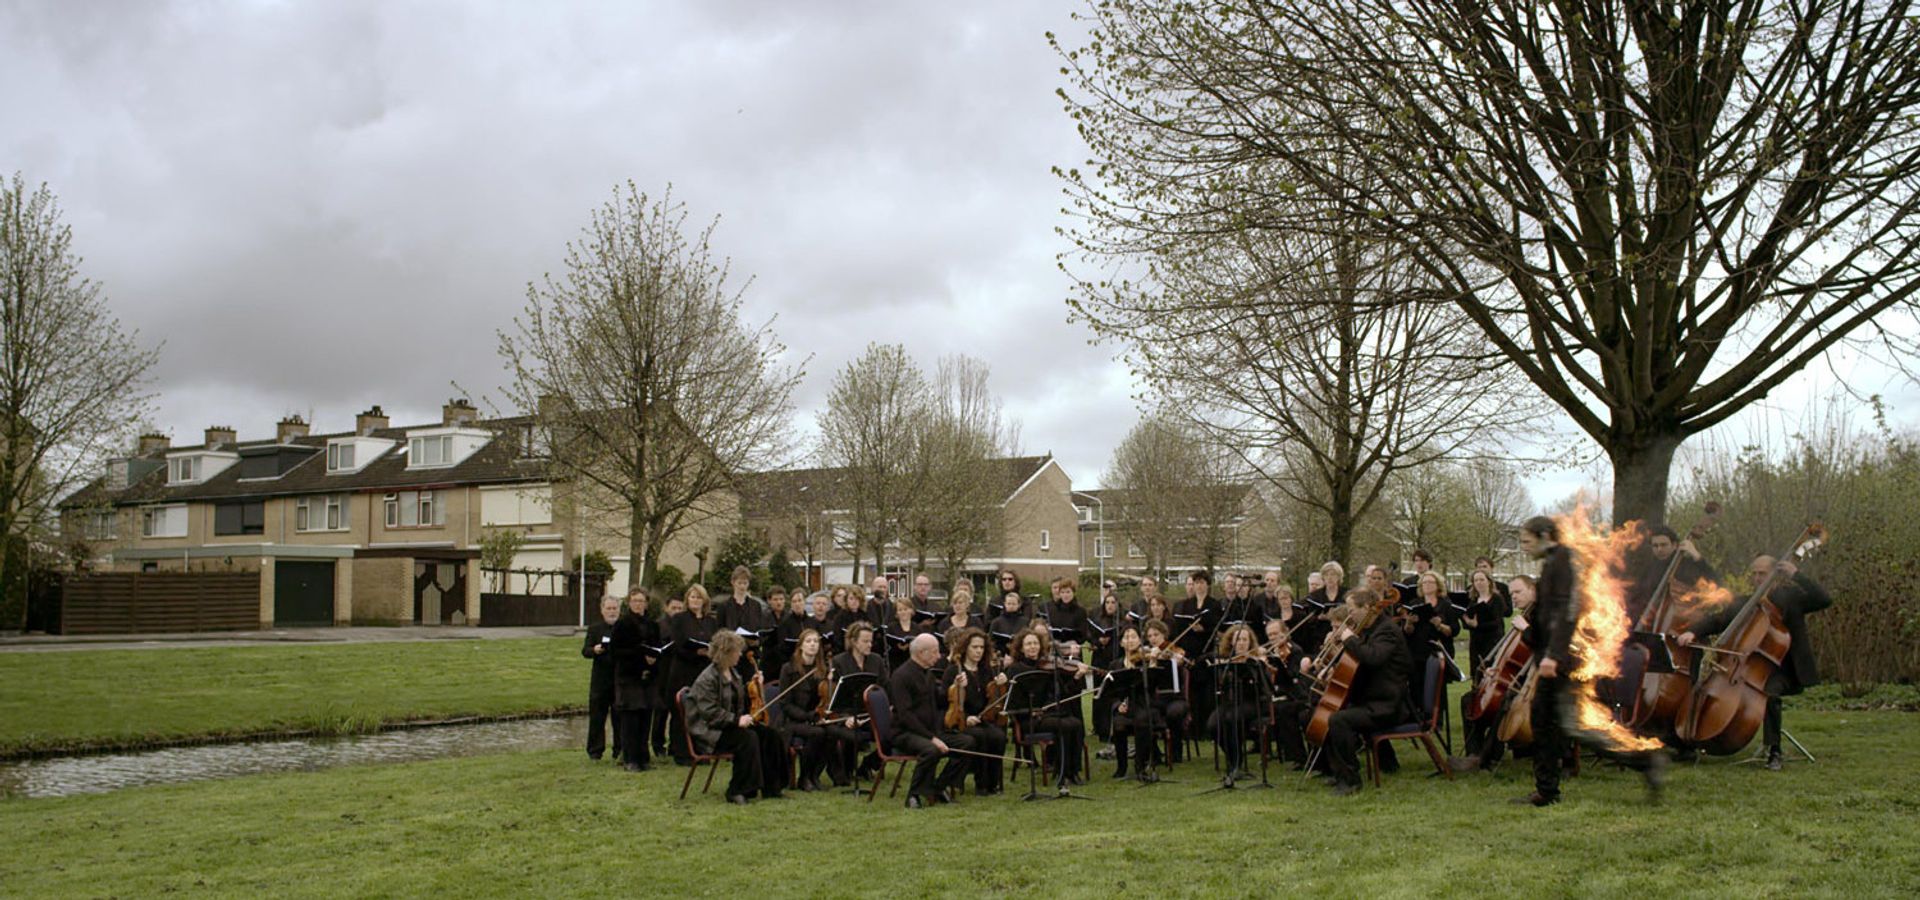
left=61, top=399, right=1279, bottom=628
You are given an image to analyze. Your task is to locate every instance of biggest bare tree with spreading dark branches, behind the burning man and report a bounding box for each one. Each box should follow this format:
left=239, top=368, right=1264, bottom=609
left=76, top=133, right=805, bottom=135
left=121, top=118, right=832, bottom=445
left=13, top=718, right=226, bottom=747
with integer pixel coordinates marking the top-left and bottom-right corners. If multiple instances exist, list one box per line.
left=1062, top=0, right=1920, bottom=522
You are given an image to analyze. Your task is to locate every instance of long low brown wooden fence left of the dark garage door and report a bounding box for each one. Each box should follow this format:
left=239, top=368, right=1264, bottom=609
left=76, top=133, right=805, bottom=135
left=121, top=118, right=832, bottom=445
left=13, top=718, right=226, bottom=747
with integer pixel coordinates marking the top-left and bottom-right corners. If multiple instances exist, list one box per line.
left=60, top=572, right=259, bottom=635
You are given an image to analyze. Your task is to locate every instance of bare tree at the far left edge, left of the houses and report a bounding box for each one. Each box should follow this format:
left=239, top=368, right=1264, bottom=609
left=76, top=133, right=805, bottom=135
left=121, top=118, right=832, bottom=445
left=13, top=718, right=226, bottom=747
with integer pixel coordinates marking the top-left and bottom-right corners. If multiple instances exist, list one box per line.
left=0, top=173, right=159, bottom=622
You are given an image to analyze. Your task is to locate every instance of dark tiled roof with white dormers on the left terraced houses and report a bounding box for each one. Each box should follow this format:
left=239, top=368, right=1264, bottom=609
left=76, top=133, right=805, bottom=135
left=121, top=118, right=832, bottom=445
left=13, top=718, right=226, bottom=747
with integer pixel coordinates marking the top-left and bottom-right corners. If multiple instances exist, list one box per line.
left=61, top=416, right=547, bottom=509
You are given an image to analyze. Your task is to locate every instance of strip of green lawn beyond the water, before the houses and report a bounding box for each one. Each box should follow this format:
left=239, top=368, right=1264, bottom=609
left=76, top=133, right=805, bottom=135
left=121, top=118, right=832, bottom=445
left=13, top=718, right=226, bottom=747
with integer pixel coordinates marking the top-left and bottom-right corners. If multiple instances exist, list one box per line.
left=0, top=637, right=588, bottom=754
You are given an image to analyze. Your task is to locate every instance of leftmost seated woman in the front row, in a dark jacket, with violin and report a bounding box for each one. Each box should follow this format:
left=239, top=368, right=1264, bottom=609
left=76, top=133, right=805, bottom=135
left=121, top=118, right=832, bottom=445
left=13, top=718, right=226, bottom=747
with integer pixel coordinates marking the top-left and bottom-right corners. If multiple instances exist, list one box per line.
left=685, top=631, right=787, bottom=806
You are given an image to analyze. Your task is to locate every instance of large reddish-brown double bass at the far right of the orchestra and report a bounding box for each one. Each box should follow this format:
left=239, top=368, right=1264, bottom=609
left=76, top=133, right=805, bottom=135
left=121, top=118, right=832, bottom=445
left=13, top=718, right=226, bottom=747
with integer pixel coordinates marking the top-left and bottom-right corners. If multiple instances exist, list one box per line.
left=1676, top=522, right=1826, bottom=756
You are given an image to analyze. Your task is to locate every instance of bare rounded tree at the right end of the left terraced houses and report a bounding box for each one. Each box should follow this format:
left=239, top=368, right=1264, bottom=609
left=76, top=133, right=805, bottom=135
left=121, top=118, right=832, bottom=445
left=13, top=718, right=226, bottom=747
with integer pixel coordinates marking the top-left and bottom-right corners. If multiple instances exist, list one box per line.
left=499, top=182, right=804, bottom=585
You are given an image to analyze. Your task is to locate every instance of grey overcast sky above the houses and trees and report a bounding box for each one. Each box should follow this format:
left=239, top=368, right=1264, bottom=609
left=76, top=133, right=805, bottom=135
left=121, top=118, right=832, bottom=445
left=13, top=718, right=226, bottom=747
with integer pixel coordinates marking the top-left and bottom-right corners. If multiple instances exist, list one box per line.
left=0, top=0, right=1920, bottom=503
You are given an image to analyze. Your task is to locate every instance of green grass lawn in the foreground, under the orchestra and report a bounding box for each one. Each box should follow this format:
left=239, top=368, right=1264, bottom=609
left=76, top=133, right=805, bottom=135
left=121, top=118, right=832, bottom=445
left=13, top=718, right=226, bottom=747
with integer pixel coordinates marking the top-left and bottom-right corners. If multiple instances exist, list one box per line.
left=0, top=710, right=1920, bottom=898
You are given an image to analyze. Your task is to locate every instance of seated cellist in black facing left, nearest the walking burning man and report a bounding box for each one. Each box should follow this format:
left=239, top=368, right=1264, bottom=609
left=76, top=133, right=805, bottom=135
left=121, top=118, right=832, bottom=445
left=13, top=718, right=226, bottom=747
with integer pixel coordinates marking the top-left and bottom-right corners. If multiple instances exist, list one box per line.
left=1327, top=587, right=1413, bottom=796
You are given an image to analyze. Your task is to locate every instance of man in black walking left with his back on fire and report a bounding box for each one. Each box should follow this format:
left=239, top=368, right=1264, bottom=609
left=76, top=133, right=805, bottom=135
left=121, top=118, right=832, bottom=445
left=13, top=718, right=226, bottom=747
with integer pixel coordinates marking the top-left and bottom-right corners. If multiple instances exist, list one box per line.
left=1521, top=510, right=1667, bottom=806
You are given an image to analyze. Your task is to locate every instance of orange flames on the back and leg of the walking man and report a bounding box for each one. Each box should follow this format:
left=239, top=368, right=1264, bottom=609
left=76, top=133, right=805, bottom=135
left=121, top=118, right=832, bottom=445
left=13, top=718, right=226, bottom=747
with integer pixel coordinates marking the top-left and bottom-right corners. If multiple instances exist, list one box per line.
left=1555, top=503, right=1661, bottom=750
